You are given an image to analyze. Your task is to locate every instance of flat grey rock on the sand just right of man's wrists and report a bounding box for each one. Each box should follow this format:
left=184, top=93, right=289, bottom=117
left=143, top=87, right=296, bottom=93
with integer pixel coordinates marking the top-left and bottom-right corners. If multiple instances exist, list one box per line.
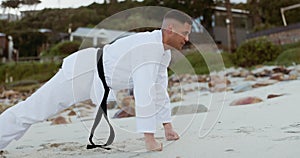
left=172, top=104, right=208, bottom=115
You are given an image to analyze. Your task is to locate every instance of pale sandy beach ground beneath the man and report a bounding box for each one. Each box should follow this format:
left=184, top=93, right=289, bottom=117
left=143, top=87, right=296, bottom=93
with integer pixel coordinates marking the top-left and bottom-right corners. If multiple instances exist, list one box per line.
left=0, top=71, right=300, bottom=158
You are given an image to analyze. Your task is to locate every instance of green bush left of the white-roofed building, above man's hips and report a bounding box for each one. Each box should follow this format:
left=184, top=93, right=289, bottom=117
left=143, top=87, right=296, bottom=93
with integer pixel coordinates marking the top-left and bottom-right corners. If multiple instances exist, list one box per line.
left=42, top=41, right=80, bottom=57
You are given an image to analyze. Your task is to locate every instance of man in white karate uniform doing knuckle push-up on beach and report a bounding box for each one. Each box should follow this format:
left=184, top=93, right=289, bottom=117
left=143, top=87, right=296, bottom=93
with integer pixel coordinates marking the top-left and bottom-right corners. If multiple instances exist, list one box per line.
left=0, top=10, right=192, bottom=151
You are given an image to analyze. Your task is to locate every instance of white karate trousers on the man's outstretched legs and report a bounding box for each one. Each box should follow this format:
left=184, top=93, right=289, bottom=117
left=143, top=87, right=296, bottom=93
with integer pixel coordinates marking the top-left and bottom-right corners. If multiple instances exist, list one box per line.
left=0, top=69, right=95, bottom=149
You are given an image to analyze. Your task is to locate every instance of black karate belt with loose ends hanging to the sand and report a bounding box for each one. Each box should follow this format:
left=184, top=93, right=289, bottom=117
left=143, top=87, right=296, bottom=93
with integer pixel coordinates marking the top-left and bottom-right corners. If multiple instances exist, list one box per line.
left=86, top=48, right=115, bottom=150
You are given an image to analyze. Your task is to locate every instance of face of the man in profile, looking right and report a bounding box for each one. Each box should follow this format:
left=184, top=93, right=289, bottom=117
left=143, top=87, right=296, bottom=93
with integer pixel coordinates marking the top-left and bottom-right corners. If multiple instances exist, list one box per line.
left=169, top=23, right=192, bottom=50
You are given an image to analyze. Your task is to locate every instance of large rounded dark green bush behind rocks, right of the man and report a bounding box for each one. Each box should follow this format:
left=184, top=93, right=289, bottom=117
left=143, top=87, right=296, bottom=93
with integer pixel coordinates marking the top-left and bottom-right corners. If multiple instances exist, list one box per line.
left=232, top=38, right=281, bottom=67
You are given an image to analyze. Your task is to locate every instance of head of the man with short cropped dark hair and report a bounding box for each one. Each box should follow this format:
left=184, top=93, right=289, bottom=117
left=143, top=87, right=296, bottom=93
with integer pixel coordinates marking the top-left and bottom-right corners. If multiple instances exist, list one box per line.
left=162, top=10, right=192, bottom=50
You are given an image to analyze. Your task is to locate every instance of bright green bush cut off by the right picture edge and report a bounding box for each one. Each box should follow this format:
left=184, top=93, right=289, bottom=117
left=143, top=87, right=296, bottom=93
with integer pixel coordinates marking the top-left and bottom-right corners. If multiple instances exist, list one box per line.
left=276, top=47, right=300, bottom=66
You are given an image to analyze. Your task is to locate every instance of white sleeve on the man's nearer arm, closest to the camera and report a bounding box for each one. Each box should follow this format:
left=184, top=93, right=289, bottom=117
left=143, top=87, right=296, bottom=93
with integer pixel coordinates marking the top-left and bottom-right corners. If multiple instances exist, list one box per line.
left=132, top=63, right=158, bottom=133
